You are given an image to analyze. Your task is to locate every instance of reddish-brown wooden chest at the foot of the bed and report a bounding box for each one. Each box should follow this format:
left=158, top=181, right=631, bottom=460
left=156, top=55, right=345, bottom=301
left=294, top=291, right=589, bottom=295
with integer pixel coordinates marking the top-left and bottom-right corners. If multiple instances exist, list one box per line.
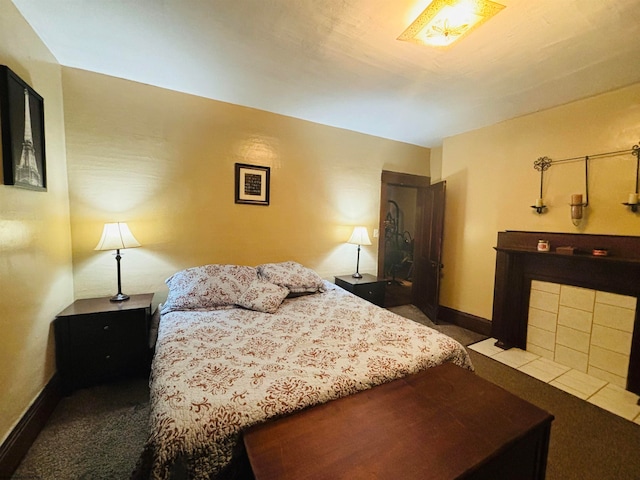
left=244, top=363, right=553, bottom=480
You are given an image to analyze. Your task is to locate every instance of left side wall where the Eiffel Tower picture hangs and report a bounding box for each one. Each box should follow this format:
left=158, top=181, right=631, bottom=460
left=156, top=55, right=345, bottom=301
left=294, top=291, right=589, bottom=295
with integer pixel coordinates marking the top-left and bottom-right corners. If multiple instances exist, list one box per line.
left=0, top=0, right=73, bottom=442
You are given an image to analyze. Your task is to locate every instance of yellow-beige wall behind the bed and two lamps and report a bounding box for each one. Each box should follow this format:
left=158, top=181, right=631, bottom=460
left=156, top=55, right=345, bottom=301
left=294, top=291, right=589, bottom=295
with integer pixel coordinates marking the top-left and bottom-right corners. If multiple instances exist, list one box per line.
left=63, top=68, right=429, bottom=302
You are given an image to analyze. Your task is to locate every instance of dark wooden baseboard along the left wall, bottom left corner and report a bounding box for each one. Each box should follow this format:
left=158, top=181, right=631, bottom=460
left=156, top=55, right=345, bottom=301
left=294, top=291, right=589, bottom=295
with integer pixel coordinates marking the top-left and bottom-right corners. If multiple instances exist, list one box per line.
left=0, top=373, right=62, bottom=478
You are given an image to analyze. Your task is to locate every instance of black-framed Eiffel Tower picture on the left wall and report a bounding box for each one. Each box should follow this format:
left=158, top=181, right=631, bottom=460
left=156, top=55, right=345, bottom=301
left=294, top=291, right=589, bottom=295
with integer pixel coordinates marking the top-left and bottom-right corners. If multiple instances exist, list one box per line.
left=0, top=65, right=47, bottom=191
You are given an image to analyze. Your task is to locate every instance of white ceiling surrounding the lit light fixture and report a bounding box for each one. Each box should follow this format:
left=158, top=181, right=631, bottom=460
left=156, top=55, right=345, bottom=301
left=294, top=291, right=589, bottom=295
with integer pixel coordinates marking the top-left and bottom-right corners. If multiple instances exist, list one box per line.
left=13, top=0, right=640, bottom=147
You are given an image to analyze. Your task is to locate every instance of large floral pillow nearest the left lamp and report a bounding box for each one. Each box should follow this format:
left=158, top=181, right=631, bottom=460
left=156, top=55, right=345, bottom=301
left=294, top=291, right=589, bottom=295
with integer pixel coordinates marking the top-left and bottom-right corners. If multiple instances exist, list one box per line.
left=162, top=265, right=258, bottom=314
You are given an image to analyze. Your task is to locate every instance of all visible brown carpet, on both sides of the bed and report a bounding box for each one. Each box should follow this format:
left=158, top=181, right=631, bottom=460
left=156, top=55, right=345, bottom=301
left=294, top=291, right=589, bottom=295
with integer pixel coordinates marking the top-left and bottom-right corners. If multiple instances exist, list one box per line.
left=12, top=305, right=640, bottom=480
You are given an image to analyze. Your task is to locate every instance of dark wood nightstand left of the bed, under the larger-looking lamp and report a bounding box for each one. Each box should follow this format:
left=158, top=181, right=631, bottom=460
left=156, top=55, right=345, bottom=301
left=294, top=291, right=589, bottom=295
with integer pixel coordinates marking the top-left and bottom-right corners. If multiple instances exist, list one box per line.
left=54, top=293, right=153, bottom=394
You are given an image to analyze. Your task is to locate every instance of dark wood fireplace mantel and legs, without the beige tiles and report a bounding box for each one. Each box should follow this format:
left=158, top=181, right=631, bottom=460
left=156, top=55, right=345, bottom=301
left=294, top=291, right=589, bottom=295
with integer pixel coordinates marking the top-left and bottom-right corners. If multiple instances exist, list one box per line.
left=491, top=231, right=640, bottom=394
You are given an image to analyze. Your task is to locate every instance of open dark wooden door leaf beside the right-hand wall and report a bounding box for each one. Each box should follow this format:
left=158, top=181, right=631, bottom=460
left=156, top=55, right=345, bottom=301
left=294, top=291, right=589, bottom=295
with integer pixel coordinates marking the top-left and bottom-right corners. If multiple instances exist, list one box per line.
left=412, top=181, right=446, bottom=322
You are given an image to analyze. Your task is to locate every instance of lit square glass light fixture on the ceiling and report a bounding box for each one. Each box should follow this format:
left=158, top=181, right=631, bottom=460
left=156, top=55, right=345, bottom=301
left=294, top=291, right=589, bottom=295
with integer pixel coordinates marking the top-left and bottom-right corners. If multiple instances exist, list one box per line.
left=398, top=0, right=504, bottom=47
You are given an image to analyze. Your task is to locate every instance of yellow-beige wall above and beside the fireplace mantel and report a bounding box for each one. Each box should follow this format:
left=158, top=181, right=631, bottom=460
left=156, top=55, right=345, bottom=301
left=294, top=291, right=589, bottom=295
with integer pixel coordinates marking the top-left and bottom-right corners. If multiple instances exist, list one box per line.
left=440, top=84, right=640, bottom=319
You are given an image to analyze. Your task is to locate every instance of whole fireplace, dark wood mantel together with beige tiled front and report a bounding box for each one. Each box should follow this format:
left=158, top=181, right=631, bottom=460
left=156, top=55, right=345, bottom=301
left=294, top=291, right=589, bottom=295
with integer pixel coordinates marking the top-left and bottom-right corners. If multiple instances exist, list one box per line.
left=491, top=231, right=640, bottom=394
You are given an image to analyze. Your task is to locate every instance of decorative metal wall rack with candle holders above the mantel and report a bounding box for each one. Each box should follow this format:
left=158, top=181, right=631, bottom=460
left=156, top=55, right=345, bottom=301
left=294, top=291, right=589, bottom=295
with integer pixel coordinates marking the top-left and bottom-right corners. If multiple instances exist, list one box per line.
left=531, top=142, right=640, bottom=221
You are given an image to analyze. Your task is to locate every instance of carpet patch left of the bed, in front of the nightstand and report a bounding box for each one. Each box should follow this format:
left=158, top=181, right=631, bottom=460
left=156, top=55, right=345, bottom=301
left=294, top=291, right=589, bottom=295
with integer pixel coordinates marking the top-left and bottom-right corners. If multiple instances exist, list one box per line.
left=11, top=379, right=149, bottom=480
